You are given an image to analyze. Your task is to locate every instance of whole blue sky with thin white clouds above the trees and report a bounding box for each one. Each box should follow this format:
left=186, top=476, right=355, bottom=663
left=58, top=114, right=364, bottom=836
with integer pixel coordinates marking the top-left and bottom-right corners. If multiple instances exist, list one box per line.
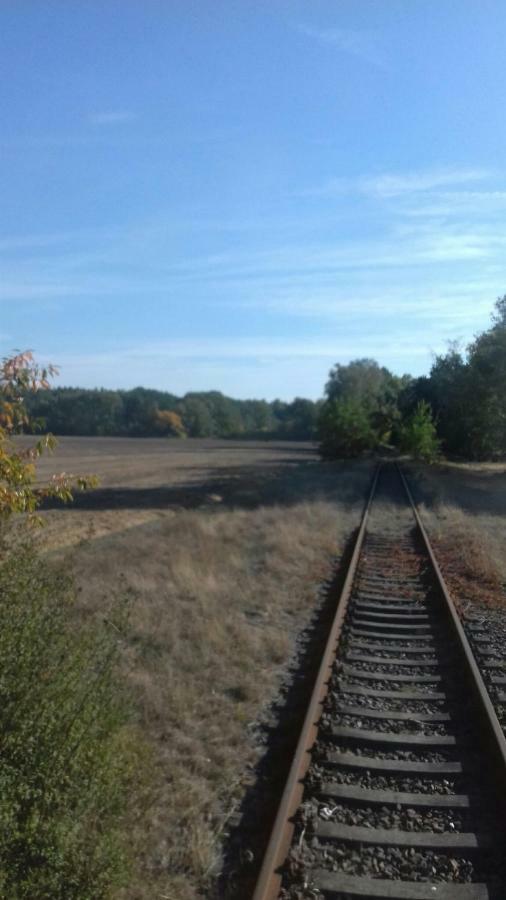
left=0, top=0, right=506, bottom=399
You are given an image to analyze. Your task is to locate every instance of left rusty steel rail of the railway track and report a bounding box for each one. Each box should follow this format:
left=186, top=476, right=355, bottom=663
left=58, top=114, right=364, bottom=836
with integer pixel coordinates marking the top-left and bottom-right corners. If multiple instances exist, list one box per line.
left=253, top=465, right=381, bottom=900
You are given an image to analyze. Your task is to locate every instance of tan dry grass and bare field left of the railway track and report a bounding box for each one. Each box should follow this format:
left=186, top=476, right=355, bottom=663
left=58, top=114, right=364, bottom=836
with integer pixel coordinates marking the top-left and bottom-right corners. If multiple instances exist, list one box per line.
left=29, top=438, right=373, bottom=900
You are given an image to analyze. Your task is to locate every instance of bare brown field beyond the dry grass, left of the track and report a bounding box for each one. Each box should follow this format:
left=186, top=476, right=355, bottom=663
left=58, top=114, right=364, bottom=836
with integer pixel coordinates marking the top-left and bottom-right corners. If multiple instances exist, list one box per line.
left=33, top=437, right=324, bottom=548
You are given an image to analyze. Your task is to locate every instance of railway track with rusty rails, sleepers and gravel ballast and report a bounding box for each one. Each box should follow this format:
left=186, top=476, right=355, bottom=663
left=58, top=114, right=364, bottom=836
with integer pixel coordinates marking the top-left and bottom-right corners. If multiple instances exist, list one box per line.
left=254, top=464, right=506, bottom=900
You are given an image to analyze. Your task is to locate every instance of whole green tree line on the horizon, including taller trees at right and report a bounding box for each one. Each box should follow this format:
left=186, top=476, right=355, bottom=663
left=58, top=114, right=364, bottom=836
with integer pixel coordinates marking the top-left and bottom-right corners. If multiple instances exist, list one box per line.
left=29, top=296, right=506, bottom=460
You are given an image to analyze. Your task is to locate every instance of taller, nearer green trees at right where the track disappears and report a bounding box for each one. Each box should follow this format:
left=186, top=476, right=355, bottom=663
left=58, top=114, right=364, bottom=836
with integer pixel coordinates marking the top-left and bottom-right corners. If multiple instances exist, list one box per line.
left=319, top=296, right=506, bottom=460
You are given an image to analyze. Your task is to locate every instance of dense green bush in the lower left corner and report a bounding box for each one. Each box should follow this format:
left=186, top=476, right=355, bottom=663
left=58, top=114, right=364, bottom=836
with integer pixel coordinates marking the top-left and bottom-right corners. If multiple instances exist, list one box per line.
left=0, top=546, right=134, bottom=900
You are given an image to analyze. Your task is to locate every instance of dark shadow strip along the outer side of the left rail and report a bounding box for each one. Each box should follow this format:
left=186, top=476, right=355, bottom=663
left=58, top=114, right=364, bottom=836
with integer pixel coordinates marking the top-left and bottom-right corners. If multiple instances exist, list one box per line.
left=213, top=529, right=358, bottom=900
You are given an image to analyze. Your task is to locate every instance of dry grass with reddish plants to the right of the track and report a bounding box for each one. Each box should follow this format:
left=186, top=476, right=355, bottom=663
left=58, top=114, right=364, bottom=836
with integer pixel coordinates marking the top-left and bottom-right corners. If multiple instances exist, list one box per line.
left=411, top=463, right=506, bottom=610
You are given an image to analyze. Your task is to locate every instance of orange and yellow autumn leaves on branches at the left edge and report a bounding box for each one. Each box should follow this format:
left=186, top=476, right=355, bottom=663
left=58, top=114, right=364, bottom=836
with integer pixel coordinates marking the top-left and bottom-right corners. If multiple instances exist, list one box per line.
left=0, top=351, right=94, bottom=521
